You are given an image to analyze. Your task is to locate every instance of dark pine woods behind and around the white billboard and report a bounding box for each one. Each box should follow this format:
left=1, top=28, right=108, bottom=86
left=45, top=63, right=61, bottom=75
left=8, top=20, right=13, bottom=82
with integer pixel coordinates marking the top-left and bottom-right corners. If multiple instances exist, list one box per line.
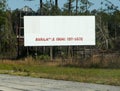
left=0, top=0, right=120, bottom=61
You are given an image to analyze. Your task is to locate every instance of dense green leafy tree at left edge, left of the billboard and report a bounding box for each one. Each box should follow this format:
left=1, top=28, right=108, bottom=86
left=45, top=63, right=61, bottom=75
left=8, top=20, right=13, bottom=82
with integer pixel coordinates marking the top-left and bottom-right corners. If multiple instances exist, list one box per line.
left=0, top=11, right=16, bottom=58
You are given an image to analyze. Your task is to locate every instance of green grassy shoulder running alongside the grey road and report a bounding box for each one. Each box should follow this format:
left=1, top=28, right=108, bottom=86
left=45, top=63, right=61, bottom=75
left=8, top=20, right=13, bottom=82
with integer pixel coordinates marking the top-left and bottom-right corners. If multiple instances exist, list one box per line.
left=0, top=60, right=120, bottom=86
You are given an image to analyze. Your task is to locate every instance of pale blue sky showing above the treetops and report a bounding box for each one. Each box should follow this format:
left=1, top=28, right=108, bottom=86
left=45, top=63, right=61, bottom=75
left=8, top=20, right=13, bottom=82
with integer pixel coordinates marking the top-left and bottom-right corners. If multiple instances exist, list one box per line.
left=7, top=0, right=120, bottom=11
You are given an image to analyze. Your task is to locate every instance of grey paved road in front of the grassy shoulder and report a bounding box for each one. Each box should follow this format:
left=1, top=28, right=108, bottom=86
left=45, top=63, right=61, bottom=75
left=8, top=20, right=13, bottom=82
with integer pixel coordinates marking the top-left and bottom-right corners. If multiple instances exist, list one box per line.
left=0, top=74, right=120, bottom=91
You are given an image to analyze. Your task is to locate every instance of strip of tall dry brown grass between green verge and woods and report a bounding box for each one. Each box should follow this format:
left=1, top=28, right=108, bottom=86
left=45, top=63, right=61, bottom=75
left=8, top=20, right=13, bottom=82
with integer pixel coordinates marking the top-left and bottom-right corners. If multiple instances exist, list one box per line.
left=0, top=54, right=120, bottom=68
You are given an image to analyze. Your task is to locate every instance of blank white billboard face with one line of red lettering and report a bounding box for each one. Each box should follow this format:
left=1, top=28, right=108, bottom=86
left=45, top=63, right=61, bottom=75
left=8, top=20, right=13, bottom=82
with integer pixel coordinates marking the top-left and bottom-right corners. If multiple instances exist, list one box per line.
left=24, top=16, right=95, bottom=46
